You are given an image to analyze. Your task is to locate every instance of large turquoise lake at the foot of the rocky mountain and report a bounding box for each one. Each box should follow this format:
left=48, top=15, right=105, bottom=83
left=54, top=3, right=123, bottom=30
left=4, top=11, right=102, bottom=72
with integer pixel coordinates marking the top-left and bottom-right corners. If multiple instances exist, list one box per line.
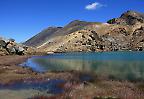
left=22, top=52, right=144, bottom=81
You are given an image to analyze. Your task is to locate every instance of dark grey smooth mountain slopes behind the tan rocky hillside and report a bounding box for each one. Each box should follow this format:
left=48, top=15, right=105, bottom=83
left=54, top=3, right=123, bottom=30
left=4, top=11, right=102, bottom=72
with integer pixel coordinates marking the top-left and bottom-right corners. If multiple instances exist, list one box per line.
left=24, top=20, right=100, bottom=47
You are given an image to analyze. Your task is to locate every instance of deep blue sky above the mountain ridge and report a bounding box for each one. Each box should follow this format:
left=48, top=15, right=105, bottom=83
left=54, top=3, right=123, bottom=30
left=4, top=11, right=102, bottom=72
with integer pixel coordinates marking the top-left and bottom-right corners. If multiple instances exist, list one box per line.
left=0, top=0, right=144, bottom=42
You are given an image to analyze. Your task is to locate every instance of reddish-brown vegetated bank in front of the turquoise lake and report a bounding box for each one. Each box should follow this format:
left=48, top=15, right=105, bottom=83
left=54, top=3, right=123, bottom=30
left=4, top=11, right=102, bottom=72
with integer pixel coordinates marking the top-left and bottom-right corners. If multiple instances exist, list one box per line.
left=0, top=55, right=144, bottom=99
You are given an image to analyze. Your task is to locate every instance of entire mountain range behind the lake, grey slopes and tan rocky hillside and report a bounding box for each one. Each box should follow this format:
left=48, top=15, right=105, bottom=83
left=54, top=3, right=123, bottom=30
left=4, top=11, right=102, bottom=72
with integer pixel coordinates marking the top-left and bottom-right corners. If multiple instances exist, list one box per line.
left=24, top=11, right=144, bottom=52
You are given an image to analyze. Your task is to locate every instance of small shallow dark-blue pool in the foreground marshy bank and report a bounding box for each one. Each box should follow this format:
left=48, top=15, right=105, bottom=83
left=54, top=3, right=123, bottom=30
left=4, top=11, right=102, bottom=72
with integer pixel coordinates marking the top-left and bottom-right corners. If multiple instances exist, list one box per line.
left=0, top=79, right=65, bottom=99
